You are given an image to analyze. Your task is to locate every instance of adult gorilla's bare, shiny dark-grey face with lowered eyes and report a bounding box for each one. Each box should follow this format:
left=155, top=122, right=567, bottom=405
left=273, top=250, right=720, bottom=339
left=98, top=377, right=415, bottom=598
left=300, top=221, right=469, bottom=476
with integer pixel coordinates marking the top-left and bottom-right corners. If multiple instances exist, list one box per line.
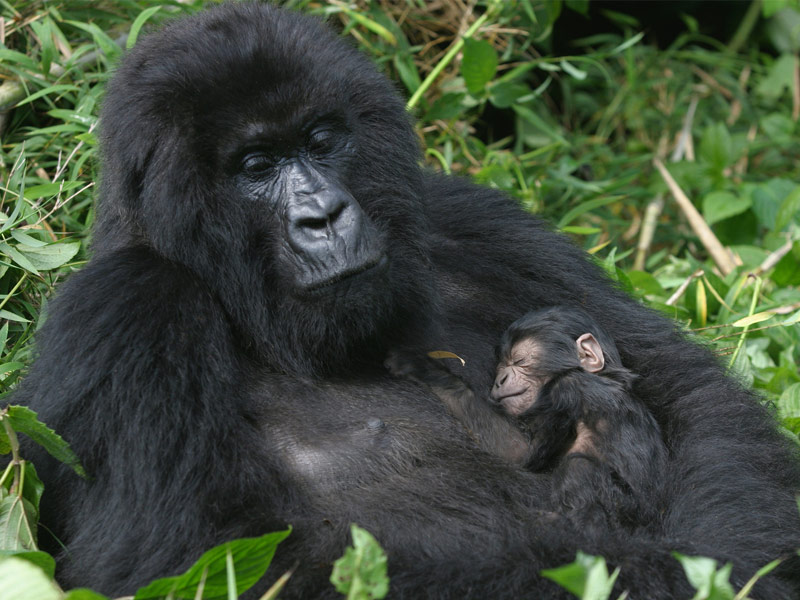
left=226, top=114, right=389, bottom=301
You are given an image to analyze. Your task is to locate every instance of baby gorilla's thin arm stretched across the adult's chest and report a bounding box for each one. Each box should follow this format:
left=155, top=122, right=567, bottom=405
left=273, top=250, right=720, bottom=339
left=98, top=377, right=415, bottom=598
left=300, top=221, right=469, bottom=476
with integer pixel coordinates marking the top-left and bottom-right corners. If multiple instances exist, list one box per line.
left=385, top=352, right=531, bottom=466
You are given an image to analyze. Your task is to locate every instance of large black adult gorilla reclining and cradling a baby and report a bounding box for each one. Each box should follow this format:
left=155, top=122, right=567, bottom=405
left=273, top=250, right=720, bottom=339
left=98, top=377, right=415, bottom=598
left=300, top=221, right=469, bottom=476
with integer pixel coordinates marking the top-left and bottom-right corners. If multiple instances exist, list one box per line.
left=14, top=4, right=800, bottom=598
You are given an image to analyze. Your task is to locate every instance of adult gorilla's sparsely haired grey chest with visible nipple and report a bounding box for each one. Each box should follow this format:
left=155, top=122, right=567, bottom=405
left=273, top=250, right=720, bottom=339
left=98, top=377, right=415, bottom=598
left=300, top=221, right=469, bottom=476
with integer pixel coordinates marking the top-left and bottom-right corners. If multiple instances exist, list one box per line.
left=247, top=376, right=471, bottom=493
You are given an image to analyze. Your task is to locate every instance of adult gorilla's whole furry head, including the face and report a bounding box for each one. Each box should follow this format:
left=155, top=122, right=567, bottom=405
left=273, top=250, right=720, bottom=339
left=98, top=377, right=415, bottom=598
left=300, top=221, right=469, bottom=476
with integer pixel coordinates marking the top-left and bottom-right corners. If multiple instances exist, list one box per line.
left=95, top=3, right=433, bottom=375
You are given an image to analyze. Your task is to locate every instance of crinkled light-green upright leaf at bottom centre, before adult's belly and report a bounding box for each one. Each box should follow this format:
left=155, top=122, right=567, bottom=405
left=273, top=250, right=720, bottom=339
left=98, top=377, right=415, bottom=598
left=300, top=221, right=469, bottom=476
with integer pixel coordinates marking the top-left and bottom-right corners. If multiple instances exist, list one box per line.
left=331, top=524, right=389, bottom=600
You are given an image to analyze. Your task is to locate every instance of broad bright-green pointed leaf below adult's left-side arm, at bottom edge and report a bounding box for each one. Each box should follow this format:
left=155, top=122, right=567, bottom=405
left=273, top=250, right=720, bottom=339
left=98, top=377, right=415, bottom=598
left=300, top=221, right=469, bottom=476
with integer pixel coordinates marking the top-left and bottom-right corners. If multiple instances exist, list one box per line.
left=134, top=529, right=291, bottom=600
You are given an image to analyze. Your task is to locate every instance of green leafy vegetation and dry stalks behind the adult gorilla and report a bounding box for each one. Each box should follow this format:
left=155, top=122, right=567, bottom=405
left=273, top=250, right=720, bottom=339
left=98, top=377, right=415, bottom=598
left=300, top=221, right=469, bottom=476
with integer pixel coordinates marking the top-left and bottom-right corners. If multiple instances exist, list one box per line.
left=0, top=0, right=800, bottom=596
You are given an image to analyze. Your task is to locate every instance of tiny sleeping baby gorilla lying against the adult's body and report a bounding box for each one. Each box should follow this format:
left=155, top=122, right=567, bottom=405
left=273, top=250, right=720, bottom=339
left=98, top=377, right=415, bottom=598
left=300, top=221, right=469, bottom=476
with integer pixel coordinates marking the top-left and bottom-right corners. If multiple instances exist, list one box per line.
left=387, top=307, right=666, bottom=531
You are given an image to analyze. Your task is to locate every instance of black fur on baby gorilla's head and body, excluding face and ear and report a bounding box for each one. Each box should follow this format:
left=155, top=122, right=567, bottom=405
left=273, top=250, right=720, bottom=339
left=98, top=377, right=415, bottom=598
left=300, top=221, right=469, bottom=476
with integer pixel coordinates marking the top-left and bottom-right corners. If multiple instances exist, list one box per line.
left=512, top=307, right=667, bottom=529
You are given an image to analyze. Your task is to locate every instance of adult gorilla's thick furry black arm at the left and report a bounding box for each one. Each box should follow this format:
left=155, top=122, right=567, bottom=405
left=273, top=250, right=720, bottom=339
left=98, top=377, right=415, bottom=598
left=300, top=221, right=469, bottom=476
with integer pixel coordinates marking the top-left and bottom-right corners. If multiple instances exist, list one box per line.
left=12, top=249, right=284, bottom=593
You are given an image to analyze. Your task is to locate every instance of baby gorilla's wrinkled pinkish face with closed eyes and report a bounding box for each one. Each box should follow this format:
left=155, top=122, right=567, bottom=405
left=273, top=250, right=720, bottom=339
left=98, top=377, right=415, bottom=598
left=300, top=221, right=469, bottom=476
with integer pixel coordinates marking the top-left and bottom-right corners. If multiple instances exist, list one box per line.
left=492, top=339, right=549, bottom=417
